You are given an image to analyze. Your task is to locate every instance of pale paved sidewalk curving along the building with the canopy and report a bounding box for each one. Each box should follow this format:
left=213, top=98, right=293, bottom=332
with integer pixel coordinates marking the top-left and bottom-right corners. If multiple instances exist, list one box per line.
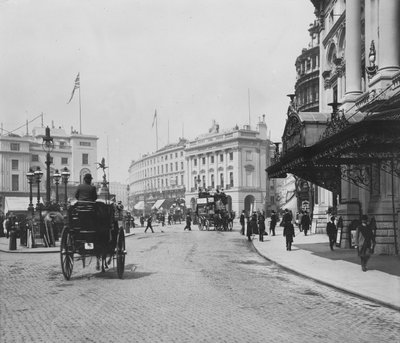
left=252, top=227, right=400, bottom=310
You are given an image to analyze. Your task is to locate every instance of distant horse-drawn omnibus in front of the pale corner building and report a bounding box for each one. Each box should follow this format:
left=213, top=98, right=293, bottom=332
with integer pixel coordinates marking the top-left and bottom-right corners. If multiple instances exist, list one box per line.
left=196, top=192, right=234, bottom=231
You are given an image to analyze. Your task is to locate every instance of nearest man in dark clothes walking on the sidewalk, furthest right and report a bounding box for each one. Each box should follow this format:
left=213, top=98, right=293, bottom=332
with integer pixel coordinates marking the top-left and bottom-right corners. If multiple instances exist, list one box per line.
left=355, top=215, right=376, bottom=272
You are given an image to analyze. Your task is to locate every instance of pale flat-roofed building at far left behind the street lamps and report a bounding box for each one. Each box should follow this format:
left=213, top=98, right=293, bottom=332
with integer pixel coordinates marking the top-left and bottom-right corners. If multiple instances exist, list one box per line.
left=0, top=126, right=98, bottom=211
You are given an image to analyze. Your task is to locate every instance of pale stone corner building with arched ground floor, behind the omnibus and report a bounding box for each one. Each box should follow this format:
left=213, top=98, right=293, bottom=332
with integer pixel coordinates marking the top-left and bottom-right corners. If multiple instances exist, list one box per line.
left=185, top=116, right=274, bottom=214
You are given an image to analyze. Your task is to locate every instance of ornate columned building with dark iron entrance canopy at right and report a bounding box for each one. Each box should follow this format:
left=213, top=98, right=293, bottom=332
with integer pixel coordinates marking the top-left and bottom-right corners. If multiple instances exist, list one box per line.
left=268, top=0, right=400, bottom=254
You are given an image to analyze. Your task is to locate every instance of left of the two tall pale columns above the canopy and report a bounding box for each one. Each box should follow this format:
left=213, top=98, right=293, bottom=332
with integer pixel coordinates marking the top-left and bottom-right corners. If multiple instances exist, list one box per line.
left=345, top=0, right=361, bottom=102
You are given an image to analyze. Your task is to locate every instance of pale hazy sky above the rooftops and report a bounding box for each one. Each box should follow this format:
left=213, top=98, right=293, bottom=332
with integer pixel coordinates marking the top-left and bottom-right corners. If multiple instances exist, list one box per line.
left=0, top=0, right=315, bottom=183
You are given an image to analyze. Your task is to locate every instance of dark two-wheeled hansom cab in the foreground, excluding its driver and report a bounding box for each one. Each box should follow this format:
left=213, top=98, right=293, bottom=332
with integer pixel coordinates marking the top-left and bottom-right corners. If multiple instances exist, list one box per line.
left=60, top=201, right=126, bottom=280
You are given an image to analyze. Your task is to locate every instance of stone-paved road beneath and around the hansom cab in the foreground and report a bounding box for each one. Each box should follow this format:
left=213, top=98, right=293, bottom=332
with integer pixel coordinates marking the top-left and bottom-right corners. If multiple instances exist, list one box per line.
left=0, top=225, right=400, bottom=343
